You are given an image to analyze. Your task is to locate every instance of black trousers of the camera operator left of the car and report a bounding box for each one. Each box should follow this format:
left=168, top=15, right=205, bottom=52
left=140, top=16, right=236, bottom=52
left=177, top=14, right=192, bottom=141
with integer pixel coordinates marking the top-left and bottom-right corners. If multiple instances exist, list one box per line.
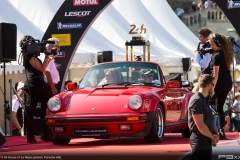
left=24, top=84, right=51, bottom=137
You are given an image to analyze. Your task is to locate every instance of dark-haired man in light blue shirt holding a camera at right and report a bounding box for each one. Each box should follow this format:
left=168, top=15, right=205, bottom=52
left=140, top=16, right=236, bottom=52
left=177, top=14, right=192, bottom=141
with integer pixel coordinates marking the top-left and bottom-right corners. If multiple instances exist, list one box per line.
left=195, top=28, right=212, bottom=75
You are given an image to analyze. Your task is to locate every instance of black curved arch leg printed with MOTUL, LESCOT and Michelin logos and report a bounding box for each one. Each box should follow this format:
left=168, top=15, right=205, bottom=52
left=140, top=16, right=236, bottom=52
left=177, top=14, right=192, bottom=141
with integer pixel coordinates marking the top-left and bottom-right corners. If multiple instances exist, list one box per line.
left=42, top=0, right=113, bottom=91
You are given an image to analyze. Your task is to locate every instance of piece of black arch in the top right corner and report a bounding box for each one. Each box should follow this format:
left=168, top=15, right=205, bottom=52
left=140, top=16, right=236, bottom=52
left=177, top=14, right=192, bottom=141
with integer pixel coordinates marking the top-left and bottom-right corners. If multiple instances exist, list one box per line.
left=215, top=0, right=240, bottom=35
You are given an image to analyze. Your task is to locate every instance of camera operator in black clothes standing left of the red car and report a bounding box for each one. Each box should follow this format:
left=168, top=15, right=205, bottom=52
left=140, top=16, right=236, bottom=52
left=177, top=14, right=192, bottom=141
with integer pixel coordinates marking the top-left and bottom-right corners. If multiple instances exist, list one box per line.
left=20, top=36, right=54, bottom=143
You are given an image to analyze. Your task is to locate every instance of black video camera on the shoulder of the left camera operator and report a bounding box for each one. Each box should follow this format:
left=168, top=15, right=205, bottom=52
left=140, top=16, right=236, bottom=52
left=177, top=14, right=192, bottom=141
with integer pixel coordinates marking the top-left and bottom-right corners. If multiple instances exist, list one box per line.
left=19, top=36, right=57, bottom=55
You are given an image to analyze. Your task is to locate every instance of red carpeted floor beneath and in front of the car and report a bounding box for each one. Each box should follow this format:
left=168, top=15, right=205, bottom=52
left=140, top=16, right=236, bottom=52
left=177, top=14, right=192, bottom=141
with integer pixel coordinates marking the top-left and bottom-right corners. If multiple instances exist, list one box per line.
left=0, top=132, right=240, bottom=160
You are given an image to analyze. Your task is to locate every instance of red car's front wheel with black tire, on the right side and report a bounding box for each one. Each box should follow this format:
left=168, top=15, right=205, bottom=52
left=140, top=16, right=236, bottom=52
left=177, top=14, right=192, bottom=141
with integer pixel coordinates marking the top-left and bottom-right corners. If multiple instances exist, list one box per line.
left=144, top=105, right=165, bottom=143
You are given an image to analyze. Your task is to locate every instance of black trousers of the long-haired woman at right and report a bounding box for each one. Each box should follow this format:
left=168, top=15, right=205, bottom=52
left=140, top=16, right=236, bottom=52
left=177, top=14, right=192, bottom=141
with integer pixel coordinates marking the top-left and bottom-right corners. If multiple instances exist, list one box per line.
left=212, top=75, right=232, bottom=129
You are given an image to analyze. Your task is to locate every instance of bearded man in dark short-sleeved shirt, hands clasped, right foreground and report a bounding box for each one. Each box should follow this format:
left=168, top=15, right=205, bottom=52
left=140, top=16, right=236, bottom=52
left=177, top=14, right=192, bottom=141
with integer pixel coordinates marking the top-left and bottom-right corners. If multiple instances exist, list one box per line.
left=188, top=74, right=218, bottom=160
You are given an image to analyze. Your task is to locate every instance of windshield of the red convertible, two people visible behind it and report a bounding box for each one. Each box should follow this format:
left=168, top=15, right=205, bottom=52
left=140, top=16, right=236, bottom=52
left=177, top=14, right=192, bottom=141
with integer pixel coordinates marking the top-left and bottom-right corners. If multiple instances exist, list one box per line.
left=79, top=62, right=161, bottom=88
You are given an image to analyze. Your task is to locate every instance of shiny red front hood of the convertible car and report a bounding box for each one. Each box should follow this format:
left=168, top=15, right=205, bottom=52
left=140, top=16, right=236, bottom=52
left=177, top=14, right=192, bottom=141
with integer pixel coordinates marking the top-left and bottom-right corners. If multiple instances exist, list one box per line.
left=67, top=86, right=158, bottom=114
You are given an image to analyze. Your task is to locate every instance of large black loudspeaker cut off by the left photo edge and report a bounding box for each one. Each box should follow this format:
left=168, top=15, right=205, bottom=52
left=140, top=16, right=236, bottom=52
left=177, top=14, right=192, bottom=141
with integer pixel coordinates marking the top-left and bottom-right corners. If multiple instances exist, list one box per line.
left=0, top=23, right=17, bottom=61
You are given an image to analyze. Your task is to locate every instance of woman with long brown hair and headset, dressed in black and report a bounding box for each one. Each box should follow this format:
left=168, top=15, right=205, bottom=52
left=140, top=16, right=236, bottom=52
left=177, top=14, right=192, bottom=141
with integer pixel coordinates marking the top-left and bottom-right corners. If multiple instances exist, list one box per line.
left=209, top=33, right=234, bottom=139
